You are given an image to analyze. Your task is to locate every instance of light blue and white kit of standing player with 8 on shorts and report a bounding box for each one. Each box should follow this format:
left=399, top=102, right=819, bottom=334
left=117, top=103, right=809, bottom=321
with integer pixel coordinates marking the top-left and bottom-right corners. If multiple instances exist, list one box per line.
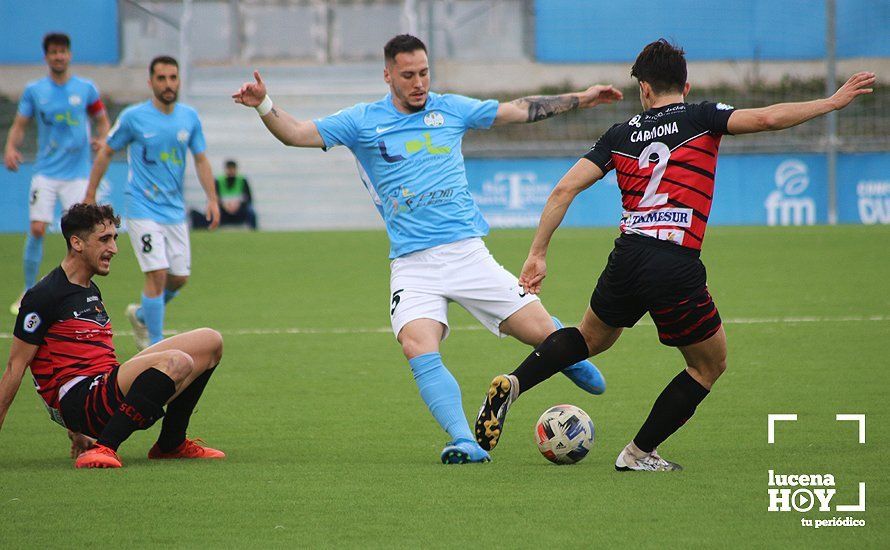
left=108, top=101, right=207, bottom=344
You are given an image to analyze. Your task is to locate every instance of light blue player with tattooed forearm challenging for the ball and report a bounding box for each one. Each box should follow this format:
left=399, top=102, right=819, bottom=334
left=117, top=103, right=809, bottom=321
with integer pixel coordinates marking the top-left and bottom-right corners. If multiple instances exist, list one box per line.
left=232, top=35, right=621, bottom=463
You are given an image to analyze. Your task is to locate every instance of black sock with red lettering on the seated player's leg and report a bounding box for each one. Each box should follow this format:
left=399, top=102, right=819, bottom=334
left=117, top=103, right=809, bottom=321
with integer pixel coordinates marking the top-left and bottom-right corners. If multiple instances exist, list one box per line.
left=97, top=368, right=176, bottom=451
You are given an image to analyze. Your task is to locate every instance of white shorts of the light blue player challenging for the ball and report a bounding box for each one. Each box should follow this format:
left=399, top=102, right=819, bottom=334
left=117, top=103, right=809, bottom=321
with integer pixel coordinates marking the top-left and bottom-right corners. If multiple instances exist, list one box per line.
left=389, top=238, right=538, bottom=340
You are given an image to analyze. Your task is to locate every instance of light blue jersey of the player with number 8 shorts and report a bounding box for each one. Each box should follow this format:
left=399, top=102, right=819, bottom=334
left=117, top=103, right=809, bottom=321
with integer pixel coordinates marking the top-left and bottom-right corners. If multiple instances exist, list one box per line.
left=108, top=101, right=207, bottom=224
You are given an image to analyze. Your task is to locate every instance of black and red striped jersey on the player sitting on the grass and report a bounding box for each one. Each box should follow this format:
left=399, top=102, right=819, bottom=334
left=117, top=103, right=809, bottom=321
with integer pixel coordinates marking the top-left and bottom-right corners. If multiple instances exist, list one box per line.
left=13, top=266, right=118, bottom=414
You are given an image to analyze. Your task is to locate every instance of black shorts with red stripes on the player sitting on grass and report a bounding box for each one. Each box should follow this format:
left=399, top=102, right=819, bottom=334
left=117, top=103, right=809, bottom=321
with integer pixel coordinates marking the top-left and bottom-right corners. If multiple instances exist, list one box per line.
left=59, top=367, right=124, bottom=438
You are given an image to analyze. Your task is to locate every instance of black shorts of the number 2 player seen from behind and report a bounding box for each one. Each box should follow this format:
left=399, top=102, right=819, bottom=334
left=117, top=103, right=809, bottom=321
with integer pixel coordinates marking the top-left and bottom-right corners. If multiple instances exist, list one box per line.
left=590, top=233, right=721, bottom=346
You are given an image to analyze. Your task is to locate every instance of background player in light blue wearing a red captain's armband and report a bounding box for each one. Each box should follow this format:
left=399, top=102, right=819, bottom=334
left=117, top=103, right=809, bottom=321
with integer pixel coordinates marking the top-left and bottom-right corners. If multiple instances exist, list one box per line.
left=3, top=33, right=109, bottom=315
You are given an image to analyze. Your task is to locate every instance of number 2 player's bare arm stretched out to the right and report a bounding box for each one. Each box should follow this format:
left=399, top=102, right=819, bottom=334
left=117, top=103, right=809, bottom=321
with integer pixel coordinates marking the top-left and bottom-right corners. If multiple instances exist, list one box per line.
left=726, top=72, right=876, bottom=134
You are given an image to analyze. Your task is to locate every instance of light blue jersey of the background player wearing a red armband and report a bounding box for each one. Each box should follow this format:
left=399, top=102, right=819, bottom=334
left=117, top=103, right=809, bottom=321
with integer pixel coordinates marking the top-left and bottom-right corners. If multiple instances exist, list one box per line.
left=18, top=76, right=104, bottom=180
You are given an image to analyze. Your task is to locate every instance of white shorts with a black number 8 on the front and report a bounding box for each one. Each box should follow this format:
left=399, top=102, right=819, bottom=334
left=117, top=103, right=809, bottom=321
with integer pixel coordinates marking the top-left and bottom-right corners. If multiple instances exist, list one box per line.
left=127, top=218, right=192, bottom=276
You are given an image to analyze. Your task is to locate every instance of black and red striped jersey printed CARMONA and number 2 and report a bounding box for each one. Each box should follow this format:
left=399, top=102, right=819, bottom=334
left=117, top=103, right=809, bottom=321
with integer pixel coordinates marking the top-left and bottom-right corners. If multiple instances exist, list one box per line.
left=584, top=102, right=733, bottom=250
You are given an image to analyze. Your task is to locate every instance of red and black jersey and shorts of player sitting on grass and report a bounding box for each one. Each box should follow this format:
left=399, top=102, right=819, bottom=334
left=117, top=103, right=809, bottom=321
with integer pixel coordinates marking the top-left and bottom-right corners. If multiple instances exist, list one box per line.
left=13, top=267, right=123, bottom=435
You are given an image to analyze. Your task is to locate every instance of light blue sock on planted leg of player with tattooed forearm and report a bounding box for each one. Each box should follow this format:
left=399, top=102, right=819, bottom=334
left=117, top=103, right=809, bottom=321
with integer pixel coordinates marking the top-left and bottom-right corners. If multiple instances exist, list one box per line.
left=408, top=352, right=475, bottom=441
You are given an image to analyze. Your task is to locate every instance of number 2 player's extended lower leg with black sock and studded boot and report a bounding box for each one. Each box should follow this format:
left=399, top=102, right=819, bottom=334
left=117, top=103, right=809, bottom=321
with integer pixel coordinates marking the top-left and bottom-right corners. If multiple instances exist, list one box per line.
left=475, top=308, right=622, bottom=450
